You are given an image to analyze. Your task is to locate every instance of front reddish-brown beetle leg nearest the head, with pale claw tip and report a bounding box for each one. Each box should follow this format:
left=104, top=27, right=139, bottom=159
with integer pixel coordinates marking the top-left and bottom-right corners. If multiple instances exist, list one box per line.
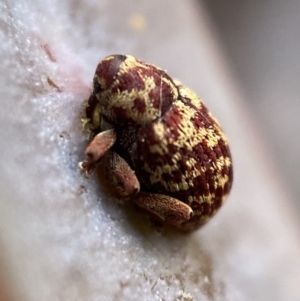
left=78, top=129, right=116, bottom=176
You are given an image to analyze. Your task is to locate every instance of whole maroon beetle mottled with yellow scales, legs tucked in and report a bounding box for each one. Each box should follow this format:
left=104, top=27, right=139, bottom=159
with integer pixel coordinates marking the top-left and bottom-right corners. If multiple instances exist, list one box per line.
left=79, top=55, right=233, bottom=230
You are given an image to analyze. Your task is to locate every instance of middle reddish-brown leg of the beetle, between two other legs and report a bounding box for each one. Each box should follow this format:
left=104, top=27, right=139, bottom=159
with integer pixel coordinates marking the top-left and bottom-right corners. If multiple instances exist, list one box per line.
left=104, top=151, right=140, bottom=198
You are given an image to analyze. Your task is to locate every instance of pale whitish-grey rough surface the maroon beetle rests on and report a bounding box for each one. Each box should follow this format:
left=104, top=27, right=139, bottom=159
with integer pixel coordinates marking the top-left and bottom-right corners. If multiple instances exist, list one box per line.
left=0, top=0, right=300, bottom=301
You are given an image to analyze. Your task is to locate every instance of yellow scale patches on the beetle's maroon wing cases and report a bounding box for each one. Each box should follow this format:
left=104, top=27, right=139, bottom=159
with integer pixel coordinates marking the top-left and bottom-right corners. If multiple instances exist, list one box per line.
left=145, top=100, right=231, bottom=204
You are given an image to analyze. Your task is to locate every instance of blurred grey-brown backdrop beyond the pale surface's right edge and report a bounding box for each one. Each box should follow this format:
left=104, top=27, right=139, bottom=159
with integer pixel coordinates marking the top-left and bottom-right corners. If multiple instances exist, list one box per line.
left=201, top=0, right=300, bottom=206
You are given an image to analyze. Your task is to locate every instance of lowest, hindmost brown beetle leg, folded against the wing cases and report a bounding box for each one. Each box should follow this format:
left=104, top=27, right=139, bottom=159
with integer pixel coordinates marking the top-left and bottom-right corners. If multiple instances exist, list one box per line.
left=134, top=192, right=193, bottom=226
